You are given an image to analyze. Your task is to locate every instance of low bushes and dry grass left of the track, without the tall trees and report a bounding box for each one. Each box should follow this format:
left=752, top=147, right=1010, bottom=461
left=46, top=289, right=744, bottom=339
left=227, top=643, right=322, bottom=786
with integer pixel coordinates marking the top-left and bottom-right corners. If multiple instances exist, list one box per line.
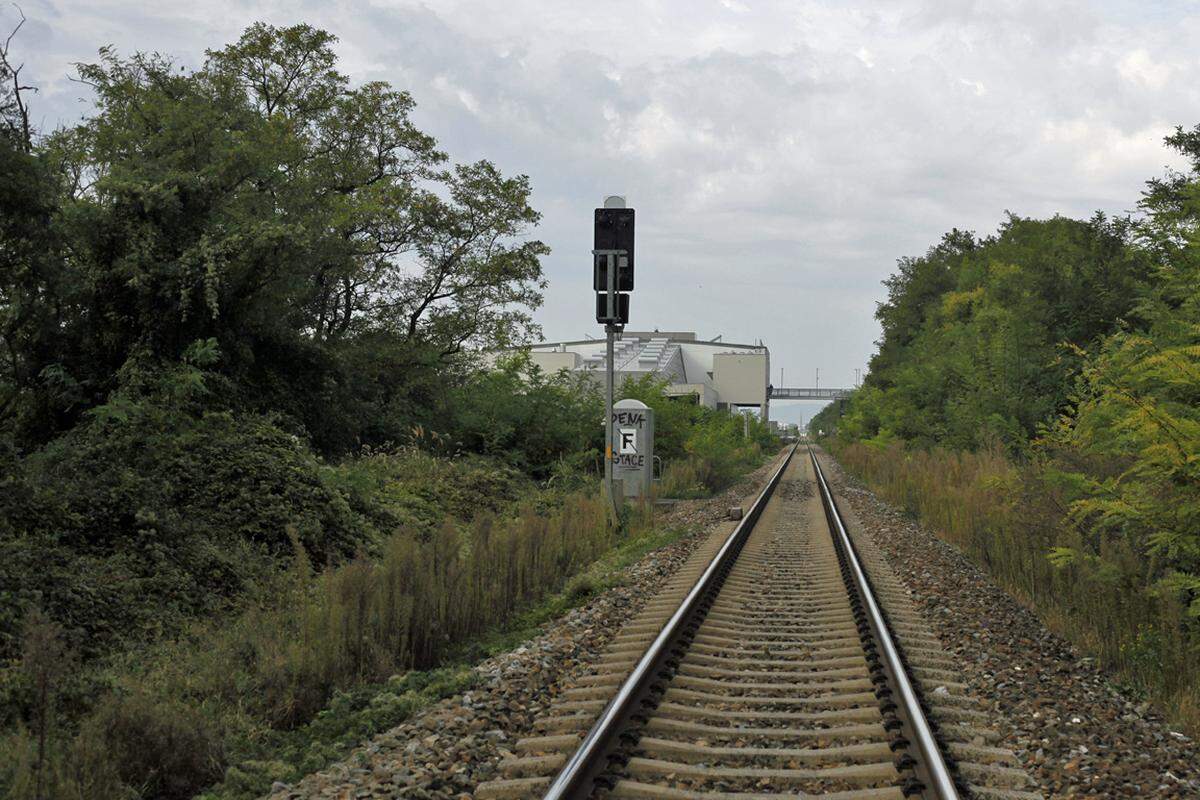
left=0, top=367, right=769, bottom=798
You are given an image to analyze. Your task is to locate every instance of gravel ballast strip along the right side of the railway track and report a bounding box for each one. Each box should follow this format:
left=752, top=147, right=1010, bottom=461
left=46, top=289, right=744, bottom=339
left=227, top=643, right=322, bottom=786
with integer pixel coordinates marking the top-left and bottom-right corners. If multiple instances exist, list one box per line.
left=822, top=450, right=1200, bottom=798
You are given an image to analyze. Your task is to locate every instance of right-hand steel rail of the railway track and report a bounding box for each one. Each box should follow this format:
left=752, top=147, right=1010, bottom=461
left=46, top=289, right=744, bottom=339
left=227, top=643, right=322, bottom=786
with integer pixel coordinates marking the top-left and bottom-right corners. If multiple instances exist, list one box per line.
left=809, top=447, right=959, bottom=800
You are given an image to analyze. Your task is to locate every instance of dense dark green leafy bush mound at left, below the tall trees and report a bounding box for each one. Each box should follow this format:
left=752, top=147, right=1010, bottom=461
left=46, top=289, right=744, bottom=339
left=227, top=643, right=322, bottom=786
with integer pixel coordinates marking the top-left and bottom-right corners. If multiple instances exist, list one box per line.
left=0, top=369, right=364, bottom=655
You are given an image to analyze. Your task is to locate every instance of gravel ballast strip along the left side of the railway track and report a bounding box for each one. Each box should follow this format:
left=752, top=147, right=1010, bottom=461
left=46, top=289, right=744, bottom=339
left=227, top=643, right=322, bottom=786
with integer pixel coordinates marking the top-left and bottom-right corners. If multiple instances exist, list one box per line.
left=268, top=459, right=775, bottom=800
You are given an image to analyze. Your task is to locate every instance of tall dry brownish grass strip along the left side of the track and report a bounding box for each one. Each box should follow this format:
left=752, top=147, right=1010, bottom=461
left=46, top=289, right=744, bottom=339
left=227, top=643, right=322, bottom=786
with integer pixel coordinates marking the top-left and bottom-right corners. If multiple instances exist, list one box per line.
left=0, top=493, right=638, bottom=800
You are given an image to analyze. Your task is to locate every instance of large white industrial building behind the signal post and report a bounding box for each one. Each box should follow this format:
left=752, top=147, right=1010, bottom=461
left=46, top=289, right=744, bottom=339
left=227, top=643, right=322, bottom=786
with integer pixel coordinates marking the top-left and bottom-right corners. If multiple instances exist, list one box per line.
left=497, top=331, right=770, bottom=420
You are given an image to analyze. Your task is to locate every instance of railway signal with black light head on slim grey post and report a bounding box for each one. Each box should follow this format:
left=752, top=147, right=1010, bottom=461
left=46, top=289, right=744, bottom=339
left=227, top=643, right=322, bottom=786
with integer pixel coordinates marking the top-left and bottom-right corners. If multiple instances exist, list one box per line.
left=592, top=196, right=634, bottom=521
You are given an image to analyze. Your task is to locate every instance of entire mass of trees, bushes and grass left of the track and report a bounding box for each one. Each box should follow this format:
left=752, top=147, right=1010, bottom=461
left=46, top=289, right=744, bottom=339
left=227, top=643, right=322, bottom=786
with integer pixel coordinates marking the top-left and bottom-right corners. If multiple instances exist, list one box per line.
left=0, top=24, right=772, bottom=800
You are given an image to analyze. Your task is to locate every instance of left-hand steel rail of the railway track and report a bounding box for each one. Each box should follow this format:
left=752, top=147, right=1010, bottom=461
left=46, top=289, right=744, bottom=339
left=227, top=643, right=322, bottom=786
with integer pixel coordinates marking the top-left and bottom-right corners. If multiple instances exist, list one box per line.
left=542, top=443, right=799, bottom=800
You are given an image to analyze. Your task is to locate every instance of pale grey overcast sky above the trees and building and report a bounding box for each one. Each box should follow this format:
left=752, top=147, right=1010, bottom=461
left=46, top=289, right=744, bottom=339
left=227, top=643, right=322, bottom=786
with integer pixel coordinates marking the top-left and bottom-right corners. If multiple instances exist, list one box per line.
left=0, top=0, right=1200, bottom=424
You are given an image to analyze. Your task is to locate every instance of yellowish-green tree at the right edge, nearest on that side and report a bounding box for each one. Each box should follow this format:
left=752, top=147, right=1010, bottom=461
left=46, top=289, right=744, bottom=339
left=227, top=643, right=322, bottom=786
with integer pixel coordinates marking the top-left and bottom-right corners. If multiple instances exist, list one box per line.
left=1043, top=126, right=1200, bottom=615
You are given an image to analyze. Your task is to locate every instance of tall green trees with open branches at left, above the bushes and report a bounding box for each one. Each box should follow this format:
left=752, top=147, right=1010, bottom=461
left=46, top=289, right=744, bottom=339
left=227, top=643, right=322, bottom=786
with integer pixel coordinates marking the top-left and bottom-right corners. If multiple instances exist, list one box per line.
left=0, top=24, right=547, bottom=451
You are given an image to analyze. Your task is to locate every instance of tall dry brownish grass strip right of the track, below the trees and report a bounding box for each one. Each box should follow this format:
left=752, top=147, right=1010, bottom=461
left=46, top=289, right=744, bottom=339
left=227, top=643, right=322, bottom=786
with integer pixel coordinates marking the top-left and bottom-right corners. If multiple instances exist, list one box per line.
left=833, top=443, right=1200, bottom=732
